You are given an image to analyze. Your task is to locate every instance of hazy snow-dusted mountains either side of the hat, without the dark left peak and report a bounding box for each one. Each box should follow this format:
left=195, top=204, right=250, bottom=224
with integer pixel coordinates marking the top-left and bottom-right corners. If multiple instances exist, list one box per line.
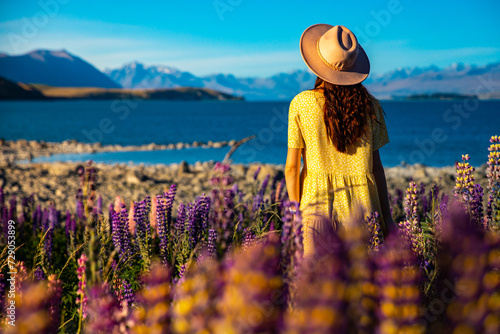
left=105, top=62, right=500, bottom=100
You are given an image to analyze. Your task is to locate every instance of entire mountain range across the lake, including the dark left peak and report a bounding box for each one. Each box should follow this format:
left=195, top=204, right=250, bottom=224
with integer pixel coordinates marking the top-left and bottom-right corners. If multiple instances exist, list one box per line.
left=0, top=50, right=500, bottom=100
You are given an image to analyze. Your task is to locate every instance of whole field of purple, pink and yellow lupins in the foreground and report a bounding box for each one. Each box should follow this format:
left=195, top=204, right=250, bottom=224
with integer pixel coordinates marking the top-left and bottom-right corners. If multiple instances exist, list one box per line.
left=0, top=136, right=500, bottom=333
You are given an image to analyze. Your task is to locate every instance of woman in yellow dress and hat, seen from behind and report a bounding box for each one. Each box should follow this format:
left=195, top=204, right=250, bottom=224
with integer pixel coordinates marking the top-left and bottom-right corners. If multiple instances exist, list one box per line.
left=285, top=24, right=396, bottom=256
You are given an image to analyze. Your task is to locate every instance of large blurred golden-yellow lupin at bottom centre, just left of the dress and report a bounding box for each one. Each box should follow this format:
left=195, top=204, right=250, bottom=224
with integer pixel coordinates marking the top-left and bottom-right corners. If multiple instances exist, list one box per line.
left=212, top=233, right=286, bottom=333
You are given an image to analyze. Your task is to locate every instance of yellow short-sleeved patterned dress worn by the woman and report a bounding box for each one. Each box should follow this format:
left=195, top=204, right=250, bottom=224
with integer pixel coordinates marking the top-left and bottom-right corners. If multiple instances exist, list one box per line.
left=288, top=90, right=389, bottom=256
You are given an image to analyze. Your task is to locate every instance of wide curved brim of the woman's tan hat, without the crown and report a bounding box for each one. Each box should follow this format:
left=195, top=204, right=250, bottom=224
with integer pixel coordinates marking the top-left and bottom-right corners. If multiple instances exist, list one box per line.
left=300, top=23, right=370, bottom=85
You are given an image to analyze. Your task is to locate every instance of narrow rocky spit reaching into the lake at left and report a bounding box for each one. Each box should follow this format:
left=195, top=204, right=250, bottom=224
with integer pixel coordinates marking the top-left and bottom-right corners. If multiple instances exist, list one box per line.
left=0, top=139, right=236, bottom=163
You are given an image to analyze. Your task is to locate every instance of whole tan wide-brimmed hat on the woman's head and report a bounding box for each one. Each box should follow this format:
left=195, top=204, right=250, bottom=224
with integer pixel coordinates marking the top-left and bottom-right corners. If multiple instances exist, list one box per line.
left=300, top=24, right=370, bottom=85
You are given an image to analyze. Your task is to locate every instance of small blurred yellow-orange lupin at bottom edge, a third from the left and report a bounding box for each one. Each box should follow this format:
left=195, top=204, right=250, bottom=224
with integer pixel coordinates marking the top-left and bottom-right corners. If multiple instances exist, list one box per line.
left=132, top=263, right=173, bottom=333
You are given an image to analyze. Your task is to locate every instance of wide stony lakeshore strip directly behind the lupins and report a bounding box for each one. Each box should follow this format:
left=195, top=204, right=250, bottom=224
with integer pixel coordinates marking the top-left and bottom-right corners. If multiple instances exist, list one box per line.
left=0, top=157, right=487, bottom=219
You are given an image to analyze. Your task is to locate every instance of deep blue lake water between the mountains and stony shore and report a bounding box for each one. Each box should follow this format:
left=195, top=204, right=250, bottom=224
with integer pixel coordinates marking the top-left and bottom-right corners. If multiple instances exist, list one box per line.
left=0, top=100, right=500, bottom=166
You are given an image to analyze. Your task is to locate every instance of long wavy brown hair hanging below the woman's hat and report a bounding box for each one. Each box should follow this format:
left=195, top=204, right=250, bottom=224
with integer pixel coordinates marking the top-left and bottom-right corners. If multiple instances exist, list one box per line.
left=314, top=77, right=375, bottom=153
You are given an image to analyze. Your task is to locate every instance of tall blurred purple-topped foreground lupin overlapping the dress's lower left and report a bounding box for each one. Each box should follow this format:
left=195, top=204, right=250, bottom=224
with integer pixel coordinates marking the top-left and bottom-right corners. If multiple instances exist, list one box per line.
left=284, top=216, right=348, bottom=334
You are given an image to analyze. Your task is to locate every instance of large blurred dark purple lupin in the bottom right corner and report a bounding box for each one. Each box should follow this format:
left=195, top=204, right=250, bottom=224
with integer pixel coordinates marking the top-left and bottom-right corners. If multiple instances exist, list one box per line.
left=431, top=205, right=500, bottom=333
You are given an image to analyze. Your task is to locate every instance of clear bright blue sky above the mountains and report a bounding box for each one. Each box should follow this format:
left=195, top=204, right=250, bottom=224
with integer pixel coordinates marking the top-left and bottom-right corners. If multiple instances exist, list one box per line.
left=0, top=0, right=500, bottom=76
